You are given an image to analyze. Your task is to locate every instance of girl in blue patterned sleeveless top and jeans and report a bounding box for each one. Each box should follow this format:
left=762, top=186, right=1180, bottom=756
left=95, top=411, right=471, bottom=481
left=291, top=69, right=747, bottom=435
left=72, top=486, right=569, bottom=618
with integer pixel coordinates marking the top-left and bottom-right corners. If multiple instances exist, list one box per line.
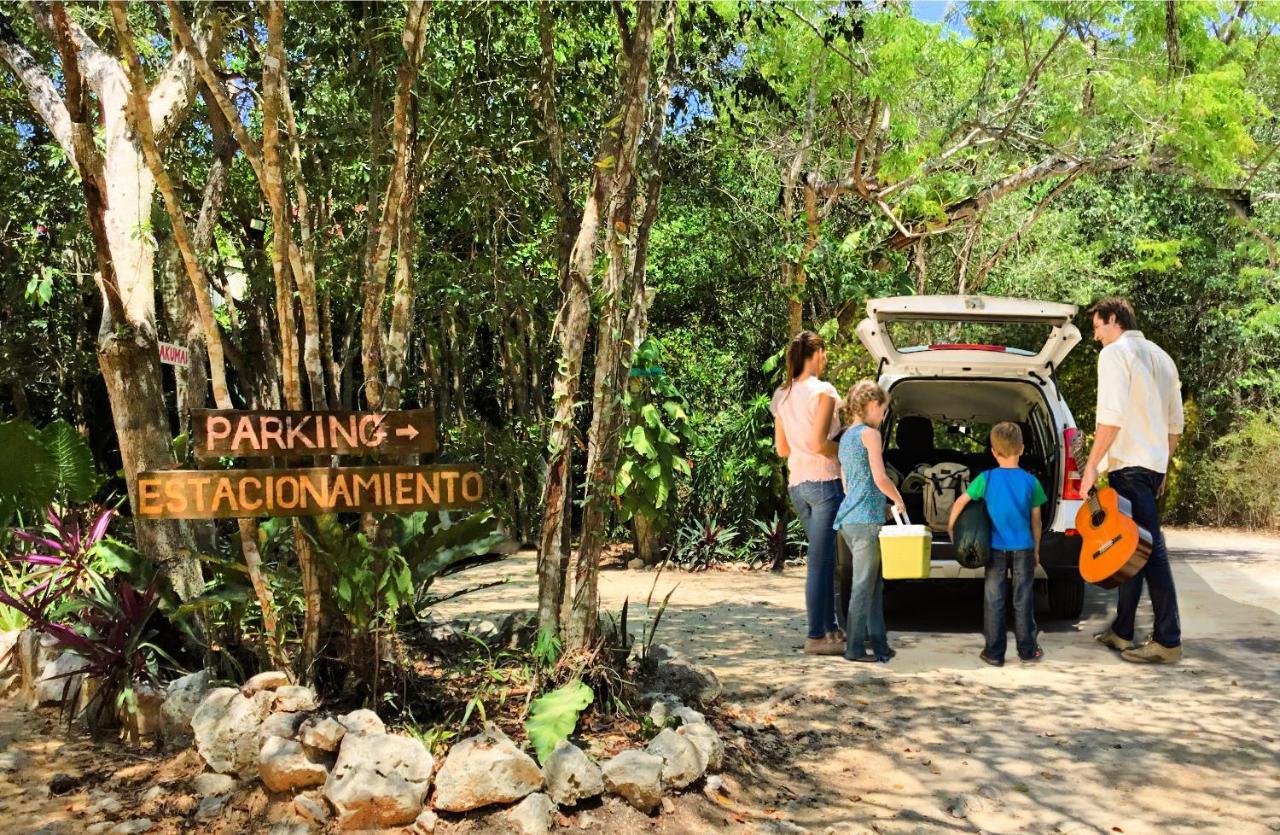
left=833, top=380, right=906, bottom=663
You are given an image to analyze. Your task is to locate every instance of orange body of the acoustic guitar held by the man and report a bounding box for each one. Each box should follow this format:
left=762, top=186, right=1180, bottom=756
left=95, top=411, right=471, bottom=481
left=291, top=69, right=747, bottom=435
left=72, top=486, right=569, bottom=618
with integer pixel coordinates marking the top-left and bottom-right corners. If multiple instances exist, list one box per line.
left=1075, top=487, right=1152, bottom=589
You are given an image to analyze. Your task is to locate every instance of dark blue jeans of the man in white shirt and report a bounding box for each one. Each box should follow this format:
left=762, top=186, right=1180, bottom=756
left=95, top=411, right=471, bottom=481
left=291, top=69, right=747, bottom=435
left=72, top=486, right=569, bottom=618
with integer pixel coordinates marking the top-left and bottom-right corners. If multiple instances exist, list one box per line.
left=1107, top=467, right=1183, bottom=648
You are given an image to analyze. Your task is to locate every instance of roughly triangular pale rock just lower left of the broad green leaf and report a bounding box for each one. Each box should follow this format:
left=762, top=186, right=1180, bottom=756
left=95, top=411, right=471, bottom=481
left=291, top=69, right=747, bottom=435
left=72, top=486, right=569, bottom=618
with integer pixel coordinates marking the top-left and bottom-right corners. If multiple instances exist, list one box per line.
left=435, top=722, right=543, bottom=812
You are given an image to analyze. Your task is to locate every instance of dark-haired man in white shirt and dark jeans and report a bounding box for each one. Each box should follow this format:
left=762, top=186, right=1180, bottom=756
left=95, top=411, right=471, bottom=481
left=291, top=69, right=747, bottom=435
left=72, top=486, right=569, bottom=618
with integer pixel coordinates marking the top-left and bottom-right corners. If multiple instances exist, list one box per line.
left=1080, top=298, right=1183, bottom=663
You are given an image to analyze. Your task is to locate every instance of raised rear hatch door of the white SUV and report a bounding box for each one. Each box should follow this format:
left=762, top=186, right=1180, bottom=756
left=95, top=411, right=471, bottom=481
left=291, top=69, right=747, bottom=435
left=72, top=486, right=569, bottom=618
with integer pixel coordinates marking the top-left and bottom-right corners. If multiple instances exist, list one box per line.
left=858, top=296, right=1080, bottom=374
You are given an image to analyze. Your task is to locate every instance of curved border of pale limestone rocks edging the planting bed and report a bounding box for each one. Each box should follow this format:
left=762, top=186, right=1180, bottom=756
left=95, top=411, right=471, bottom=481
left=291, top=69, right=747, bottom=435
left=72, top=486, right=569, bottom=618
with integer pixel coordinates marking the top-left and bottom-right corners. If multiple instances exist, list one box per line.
left=0, top=624, right=724, bottom=835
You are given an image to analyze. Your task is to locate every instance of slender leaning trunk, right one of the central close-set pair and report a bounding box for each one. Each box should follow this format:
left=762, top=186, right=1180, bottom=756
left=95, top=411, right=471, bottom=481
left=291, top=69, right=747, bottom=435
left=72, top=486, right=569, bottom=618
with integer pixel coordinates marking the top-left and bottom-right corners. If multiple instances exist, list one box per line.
left=566, top=3, right=675, bottom=648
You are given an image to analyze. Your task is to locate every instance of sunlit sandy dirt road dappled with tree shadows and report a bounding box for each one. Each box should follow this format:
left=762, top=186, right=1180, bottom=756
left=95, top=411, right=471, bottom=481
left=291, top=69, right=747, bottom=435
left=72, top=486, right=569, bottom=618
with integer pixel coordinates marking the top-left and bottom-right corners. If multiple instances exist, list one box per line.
left=434, top=531, right=1280, bottom=835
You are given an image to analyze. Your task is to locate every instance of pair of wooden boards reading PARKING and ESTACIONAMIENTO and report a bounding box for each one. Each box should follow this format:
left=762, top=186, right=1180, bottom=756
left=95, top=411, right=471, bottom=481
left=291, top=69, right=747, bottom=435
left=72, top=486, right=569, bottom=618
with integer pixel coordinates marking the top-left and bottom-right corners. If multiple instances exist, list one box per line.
left=134, top=409, right=485, bottom=519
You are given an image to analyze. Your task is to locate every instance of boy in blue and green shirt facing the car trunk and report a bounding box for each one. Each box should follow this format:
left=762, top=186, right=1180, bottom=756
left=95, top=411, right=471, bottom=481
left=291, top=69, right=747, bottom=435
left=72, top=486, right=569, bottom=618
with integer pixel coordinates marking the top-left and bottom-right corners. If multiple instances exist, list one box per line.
left=948, top=423, right=1047, bottom=667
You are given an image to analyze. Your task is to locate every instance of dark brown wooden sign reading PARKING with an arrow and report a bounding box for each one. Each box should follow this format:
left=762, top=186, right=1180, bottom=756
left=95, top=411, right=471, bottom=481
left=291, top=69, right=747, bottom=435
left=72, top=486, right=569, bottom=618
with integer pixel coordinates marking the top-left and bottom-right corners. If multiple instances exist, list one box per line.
left=192, top=409, right=438, bottom=458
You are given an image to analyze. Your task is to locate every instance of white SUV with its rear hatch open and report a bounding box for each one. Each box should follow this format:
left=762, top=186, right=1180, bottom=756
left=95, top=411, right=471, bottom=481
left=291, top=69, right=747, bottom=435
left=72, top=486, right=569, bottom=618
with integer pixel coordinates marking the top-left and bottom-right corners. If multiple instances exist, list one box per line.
left=858, top=296, right=1084, bottom=619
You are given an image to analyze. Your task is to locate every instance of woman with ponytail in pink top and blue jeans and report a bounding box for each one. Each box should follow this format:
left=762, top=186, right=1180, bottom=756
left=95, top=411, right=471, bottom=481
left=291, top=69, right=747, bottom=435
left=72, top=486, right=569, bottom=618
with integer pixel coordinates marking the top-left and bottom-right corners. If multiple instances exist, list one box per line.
left=769, top=330, right=845, bottom=656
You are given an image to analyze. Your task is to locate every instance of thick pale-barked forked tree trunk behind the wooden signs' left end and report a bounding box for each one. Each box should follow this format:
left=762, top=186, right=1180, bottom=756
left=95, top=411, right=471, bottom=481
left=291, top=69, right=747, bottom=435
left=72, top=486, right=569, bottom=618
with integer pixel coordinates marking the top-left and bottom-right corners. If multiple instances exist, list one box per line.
left=0, top=4, right=204, bottom=599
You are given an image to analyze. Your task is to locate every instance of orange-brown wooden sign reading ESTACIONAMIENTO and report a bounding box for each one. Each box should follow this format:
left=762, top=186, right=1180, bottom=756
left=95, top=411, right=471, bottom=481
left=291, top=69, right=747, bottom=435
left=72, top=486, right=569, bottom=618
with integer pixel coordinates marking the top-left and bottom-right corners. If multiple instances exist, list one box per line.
left=137, top=464, right=485, bottom=519
